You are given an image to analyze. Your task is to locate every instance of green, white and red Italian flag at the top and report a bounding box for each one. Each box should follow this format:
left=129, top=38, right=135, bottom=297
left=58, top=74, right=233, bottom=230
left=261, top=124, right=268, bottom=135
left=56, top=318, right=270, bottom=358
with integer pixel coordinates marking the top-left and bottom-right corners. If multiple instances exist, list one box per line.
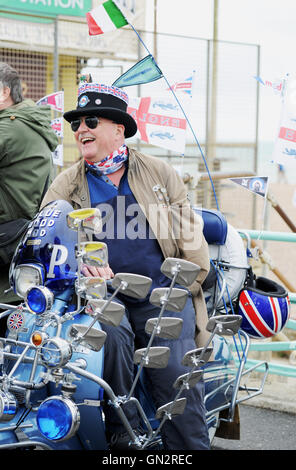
left=86, top=0, right=128, bottom=36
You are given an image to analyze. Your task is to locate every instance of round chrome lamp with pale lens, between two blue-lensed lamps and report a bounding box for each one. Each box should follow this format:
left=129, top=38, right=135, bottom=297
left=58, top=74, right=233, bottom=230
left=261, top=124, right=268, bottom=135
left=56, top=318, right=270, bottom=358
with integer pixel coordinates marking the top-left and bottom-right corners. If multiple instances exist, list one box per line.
left=40, top=337, right=72, bottom=368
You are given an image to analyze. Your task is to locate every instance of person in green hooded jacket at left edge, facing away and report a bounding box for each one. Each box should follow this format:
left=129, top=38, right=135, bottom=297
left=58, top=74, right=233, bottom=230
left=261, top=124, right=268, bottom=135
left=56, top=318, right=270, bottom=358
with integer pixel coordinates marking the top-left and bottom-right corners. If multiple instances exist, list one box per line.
left=0, top=62, right=58, bottom=312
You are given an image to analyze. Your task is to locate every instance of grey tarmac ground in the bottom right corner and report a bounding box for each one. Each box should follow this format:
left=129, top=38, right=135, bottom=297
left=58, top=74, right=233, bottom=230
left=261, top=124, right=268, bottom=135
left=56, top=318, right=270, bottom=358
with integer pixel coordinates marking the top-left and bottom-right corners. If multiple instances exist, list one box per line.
left=212, top=405, right=296, bottom=450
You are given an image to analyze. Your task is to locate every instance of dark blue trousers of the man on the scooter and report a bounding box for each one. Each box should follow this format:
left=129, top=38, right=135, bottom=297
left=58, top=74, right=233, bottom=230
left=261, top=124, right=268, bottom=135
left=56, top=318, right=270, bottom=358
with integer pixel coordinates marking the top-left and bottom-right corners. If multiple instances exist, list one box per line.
left=102, top=297, right=210, bottom=450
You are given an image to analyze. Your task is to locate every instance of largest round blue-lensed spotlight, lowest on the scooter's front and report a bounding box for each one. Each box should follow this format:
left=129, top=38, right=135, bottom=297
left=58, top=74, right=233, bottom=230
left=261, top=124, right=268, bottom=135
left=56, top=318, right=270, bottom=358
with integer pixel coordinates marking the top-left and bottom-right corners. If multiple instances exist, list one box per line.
left=36, top=396, right=80, bottom=441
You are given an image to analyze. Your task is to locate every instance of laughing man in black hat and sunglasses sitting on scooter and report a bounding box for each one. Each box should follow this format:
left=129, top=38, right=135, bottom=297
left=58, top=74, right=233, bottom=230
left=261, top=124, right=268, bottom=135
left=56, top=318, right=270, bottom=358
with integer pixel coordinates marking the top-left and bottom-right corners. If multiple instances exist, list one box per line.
left=42, top=82, right=210, bottom=450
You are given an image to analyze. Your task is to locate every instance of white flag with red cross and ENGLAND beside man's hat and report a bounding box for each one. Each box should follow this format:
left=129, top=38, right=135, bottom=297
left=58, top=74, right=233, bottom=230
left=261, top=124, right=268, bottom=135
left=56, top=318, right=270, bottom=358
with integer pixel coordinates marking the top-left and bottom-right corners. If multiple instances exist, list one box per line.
left=127, top=96, right=186, bottom=153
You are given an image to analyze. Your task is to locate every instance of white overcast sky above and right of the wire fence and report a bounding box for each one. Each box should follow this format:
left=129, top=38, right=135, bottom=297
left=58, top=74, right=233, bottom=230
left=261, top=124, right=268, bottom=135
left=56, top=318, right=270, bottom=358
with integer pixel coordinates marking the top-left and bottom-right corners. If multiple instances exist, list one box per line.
left=147, top=0, right=296, bottom=141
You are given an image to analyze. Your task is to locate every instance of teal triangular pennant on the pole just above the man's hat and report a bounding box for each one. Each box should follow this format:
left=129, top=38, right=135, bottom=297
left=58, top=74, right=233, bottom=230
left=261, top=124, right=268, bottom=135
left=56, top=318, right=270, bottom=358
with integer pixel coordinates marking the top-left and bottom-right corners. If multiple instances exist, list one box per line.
left=113, top=54, right=163, bottom=88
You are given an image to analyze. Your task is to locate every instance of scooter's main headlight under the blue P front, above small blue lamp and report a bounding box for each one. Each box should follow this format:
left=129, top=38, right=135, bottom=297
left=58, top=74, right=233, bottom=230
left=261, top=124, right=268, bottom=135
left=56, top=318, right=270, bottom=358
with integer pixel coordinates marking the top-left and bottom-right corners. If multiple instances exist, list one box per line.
left=14, top=264, right=44, bottom=298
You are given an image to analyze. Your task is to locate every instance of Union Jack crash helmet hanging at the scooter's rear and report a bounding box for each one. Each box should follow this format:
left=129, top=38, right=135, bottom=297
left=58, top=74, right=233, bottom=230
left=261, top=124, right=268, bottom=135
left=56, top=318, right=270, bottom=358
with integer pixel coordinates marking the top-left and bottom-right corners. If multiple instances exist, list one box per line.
left=237, top=277, right=290, bottom=339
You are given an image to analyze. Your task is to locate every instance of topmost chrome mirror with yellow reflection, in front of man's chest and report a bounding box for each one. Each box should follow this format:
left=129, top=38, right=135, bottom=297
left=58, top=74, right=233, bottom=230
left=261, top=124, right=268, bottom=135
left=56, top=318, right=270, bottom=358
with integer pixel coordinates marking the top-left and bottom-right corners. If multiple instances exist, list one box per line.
left=67, top=208, right=102, bottom=233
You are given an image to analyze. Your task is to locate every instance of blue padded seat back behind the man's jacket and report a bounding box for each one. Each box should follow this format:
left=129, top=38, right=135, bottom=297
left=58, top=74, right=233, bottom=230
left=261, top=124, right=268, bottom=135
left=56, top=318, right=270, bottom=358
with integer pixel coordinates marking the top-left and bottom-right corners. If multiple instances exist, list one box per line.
left=193, top=207, right=227, bottom=245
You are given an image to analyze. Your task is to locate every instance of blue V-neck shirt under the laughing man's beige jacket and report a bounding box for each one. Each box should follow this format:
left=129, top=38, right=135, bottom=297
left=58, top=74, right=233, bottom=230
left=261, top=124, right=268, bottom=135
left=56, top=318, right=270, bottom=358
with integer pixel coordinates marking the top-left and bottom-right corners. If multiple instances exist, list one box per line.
left=87, top=168, right=170, bottom=296
